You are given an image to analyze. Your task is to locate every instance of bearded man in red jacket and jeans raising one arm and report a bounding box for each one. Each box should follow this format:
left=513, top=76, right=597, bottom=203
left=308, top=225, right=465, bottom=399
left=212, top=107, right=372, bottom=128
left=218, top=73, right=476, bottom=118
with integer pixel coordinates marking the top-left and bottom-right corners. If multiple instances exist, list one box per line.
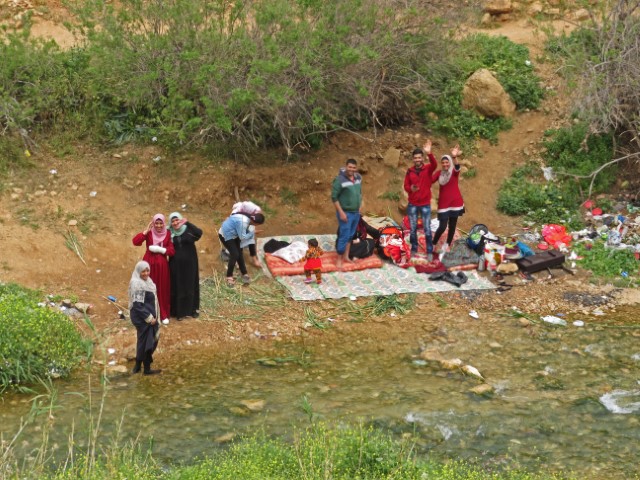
left=404, top=140, right=438, bottom=260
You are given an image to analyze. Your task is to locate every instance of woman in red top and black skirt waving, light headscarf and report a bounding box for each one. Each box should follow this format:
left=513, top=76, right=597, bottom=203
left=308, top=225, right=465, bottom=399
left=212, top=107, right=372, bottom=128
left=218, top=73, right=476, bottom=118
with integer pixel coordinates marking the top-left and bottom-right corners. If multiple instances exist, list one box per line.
left=432, top=145, right=464, bottom=252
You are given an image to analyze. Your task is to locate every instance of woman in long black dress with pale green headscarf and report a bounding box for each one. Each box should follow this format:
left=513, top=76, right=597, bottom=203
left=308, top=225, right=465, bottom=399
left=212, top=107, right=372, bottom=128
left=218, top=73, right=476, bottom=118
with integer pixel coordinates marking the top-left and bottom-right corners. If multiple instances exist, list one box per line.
left=169, top=212, right=202, bottom=321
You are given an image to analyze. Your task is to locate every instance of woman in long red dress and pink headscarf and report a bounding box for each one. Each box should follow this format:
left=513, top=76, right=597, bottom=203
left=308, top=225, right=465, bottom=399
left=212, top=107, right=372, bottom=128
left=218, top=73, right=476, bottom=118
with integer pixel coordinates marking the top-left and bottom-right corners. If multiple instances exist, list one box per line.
left=133, top=213, right=175, bottom=325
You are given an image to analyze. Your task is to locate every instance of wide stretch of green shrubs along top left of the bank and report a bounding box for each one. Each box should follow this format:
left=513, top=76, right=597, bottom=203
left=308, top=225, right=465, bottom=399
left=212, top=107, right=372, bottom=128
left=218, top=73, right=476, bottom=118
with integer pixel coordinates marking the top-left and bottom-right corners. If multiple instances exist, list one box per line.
left=0, top=0, right=452, bottom=154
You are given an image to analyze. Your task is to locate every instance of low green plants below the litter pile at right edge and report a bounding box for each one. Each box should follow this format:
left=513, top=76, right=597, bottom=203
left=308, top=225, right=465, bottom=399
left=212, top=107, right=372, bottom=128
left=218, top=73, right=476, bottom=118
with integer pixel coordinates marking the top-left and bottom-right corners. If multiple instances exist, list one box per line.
left=575, top=242, right=639, bottom=278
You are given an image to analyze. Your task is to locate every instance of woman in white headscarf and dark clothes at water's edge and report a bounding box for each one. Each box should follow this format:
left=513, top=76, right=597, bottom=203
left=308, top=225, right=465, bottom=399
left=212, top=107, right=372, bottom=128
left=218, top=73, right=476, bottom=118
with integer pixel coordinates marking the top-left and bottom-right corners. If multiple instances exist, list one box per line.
left=129, top=260, right=162, bottom=375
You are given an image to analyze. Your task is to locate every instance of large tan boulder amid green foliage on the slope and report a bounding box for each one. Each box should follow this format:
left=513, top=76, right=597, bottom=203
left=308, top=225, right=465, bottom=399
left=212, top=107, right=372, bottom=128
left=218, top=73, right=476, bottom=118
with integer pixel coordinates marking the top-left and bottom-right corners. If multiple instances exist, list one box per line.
left=462, top=68, right=516, bottom=118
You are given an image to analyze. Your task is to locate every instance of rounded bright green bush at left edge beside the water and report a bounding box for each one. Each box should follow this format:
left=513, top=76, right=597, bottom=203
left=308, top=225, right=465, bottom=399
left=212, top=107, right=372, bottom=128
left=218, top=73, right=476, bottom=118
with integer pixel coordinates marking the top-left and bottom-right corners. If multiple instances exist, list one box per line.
left=0, top=284, right=85, bottom=391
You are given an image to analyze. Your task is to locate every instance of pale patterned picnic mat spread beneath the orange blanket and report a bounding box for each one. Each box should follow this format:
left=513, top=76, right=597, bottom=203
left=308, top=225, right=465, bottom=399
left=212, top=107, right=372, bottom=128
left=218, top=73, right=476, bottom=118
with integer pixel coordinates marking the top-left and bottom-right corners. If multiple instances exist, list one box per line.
left=258, top=235, right=495, bottom=301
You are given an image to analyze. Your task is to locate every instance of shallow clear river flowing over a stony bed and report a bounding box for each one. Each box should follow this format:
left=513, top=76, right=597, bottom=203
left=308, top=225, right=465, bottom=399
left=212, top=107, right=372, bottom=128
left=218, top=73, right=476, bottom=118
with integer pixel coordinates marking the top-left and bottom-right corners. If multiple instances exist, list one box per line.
left=0, top=310, right=640, bottom=478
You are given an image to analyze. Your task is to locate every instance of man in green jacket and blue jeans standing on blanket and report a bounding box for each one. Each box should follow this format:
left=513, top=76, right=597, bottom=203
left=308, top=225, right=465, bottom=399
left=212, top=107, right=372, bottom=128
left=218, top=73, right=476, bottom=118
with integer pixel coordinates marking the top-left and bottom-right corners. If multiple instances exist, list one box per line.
left=331, top=158, right=362, bottom=270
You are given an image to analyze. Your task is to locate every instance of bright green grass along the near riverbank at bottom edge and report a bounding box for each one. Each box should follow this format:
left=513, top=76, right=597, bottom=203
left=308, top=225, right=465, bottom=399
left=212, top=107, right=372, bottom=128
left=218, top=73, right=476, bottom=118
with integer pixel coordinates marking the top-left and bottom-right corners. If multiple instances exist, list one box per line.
left=0, top=423, right=561, bottom=480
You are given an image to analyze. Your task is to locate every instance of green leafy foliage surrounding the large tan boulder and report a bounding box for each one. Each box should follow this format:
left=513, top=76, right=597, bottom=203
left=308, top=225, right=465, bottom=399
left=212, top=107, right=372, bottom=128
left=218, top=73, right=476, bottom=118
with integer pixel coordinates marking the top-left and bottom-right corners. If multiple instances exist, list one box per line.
left=420, top=34, right=544, bottom=142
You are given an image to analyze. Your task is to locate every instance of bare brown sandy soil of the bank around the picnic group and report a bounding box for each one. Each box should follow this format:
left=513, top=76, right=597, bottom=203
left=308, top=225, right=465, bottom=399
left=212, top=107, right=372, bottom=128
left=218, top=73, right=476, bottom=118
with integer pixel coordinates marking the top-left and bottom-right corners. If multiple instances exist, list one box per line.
left=0, top=6, right=637, bottom=368
